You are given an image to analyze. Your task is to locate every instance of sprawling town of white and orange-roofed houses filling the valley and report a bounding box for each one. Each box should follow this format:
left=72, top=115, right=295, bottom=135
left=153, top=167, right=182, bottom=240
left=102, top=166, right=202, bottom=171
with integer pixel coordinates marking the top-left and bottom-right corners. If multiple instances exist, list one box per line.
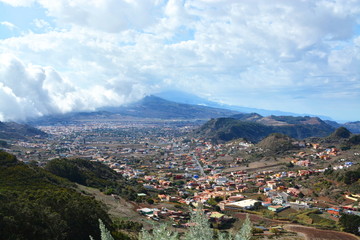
left=2, top=120, right=360, bottom=238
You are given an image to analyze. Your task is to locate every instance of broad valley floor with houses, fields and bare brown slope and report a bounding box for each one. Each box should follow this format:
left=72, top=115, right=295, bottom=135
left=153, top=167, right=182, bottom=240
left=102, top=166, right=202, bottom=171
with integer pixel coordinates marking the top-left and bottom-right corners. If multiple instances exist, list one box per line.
left=3, top=111, right=360, bottom=239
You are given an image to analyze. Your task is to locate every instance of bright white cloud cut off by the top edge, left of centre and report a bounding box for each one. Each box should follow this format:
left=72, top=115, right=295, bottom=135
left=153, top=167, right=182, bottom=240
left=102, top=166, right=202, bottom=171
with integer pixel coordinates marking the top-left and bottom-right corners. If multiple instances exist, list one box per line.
left=32, top=0, right=166, bottom=32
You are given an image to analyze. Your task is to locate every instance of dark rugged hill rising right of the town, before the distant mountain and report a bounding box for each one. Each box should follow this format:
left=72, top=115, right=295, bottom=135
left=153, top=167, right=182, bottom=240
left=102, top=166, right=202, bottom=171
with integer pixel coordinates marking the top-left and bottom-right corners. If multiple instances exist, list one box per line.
left=195, top=114, right=334, bottom=142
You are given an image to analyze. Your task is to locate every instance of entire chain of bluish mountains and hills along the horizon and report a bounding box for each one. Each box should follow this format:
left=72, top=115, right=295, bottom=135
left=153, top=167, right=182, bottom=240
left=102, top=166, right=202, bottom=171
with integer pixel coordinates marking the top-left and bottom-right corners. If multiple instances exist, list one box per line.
left=6, top=93, right=360, bottom=142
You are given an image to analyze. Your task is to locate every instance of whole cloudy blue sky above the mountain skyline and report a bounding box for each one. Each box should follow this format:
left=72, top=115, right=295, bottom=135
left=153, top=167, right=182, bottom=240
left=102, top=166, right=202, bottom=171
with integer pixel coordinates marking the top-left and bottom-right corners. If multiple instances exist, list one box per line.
left=0, top=0, right=360, bottom=121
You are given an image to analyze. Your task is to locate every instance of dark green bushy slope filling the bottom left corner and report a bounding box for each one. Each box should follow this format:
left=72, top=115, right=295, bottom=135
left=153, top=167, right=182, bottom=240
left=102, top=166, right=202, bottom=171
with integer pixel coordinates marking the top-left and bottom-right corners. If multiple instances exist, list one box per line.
left=0, top=151, right=111, bottom=240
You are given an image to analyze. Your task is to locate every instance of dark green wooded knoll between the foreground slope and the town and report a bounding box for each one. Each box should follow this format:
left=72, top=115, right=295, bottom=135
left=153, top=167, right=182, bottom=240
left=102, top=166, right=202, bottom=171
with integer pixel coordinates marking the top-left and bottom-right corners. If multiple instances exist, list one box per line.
left=45, top=158, right=146, bottom=201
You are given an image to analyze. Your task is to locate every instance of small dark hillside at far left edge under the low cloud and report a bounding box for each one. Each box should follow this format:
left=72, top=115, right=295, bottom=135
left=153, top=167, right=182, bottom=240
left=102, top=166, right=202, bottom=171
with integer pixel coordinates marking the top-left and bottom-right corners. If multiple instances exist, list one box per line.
left=0, top=122, right=47, bottom=139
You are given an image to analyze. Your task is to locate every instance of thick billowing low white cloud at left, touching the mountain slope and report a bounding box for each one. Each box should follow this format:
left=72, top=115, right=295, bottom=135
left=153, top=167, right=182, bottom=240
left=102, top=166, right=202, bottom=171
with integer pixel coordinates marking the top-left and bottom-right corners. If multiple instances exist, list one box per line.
left=0, top=55, right=143, bottom=121
